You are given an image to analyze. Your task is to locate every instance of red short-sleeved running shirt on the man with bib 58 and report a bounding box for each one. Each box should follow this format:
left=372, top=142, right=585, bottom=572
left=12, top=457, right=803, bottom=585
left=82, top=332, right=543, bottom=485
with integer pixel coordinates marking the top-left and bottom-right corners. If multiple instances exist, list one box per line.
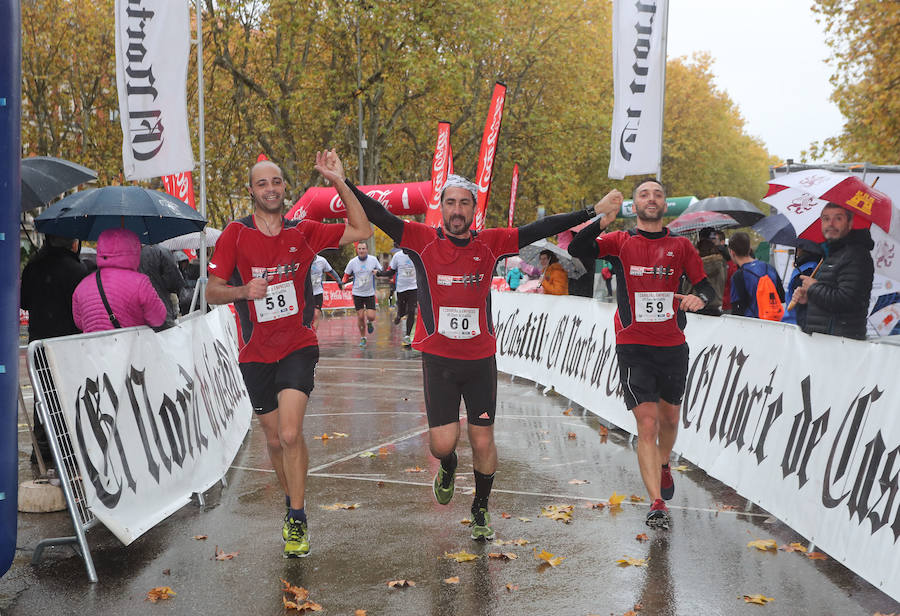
left=209, top=216, right=344, bottom=363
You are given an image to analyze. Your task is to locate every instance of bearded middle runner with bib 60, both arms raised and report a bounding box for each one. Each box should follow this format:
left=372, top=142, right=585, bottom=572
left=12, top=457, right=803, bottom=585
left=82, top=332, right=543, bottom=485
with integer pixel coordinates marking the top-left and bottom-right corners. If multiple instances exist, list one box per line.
left=353, top=175, right=622, bottom=540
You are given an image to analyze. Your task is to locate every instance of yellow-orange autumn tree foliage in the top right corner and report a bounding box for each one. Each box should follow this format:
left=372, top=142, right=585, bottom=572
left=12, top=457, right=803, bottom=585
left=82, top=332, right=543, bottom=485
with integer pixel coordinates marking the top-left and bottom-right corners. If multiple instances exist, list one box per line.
left=807, top=0, right=900, bottom=164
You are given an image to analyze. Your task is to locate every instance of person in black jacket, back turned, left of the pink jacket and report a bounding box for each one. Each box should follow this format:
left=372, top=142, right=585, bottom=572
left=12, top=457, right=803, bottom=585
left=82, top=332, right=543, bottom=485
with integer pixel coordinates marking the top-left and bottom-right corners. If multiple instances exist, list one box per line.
left=20, top=235, right=87, bottom=465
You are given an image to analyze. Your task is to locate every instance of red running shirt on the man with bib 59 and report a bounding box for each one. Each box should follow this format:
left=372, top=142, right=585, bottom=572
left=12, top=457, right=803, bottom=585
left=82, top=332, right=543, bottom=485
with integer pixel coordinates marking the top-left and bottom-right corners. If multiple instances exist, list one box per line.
left=596, top=229, right=706, bottom=347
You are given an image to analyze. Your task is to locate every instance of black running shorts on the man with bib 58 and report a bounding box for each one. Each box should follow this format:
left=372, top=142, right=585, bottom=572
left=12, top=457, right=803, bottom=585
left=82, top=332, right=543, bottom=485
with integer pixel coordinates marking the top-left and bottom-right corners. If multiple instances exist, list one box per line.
left=240, top=345, right=319, bottom=415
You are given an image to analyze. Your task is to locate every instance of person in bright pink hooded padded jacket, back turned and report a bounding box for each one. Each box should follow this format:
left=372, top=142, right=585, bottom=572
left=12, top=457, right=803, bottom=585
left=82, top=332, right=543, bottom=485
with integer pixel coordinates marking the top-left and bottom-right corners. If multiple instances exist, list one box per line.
left=72, top=229, right=166, bottom=332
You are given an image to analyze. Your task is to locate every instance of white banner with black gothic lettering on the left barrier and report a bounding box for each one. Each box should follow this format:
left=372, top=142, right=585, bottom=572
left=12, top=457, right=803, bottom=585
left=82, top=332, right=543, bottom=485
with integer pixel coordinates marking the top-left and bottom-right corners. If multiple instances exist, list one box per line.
left=44, top=307, right=252, bottom=545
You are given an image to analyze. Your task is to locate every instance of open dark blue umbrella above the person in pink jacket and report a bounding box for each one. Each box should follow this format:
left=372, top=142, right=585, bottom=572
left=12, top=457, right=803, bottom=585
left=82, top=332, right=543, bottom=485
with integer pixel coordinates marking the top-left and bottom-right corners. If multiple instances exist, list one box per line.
left=34, top=186, right=206, bottom=244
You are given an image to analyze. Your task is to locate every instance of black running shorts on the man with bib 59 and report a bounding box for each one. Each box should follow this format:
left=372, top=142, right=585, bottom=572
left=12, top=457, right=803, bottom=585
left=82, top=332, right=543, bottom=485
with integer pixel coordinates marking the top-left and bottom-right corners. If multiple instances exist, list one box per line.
left=616, top=343, right=688, bottom=410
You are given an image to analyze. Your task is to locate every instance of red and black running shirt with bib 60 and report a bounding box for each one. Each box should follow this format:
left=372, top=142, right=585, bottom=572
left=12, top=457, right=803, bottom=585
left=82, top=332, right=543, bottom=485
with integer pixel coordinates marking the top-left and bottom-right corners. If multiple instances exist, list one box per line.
left=400, top=221, right=519, bottom=359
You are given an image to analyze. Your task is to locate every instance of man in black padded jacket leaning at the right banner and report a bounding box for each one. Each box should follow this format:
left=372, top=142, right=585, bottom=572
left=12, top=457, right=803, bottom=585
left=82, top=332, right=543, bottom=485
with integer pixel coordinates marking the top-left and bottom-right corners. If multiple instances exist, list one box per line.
left=794, top=203, right=875, bottom=340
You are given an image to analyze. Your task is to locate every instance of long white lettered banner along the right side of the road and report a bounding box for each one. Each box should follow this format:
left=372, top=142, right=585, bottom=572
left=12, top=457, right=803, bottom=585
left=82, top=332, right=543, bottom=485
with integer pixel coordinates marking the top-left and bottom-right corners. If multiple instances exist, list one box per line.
left=491, top=292, right=900, bottom=600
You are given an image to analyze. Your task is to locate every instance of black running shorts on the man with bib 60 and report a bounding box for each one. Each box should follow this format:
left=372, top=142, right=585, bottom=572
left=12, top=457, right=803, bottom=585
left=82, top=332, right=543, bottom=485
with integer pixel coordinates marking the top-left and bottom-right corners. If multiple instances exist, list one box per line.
left=422, top=353, right=497, bottom=428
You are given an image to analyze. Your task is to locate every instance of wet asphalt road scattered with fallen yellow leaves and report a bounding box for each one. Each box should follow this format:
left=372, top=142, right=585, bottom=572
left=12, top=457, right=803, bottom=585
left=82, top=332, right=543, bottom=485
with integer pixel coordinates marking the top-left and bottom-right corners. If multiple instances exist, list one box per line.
left=0, top=311, right=900, bottom=616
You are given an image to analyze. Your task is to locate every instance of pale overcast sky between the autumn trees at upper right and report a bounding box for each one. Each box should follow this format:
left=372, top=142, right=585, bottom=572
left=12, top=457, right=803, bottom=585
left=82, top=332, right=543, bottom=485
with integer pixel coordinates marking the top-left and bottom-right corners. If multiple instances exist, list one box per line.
left=668, top=0, right=843, bottom=161
